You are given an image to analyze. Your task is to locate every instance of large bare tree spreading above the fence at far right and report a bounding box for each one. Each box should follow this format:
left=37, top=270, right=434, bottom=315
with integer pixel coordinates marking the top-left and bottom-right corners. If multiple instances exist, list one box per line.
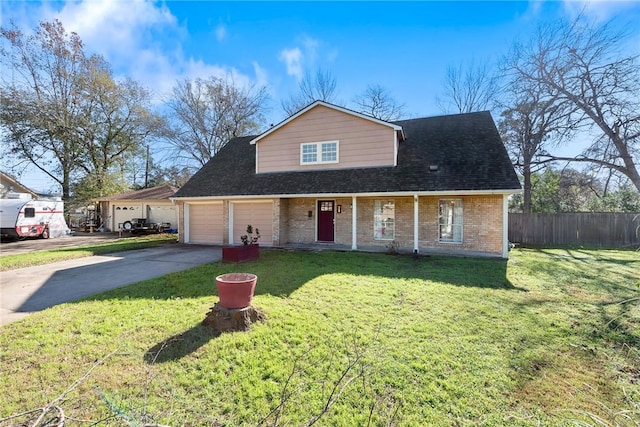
left=509, top=16, right=640, bottom=190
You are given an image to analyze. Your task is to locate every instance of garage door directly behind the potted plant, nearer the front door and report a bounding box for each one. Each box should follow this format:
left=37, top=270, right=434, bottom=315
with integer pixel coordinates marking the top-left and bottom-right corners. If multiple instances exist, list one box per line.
left=233, top=201, right=273, bottom=246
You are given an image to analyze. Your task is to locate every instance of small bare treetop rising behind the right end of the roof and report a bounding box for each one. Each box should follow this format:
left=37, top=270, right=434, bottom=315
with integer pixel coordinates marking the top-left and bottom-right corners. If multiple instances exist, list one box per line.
left=436, top=60, right=499, bottom=113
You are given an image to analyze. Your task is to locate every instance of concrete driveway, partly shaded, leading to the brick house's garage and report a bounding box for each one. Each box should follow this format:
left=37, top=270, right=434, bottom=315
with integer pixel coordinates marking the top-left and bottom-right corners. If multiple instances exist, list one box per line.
left=0, top=243, right=222, bottom=325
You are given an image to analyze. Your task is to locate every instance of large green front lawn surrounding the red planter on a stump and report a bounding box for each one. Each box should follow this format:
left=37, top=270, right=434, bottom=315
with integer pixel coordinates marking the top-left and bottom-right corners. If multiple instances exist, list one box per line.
left=0, top=249, right=640, bottom=426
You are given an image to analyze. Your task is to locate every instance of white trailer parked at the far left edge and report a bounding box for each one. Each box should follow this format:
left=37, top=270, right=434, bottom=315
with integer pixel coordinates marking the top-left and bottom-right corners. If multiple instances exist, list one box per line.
left=0, top=194, right=71, bottom=239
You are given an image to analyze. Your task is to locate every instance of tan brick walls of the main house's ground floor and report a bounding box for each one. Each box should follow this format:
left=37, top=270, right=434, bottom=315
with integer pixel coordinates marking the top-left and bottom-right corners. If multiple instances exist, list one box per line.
left=178, top=195, right=503, bottom=256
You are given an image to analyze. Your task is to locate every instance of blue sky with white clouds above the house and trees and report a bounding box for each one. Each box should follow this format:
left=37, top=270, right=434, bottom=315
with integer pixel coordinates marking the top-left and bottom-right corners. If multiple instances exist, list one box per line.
left=1, top=0, right=640, bottom=190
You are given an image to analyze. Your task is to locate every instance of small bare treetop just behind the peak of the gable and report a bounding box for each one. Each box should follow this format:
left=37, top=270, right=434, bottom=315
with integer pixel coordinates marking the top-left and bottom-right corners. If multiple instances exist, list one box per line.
left=281, top=69, right=336, bottom=116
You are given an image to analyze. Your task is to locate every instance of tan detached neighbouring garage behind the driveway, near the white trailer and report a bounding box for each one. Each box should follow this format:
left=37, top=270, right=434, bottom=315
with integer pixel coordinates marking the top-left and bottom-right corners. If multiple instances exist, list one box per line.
left=94, top=185, right=178, bottom=231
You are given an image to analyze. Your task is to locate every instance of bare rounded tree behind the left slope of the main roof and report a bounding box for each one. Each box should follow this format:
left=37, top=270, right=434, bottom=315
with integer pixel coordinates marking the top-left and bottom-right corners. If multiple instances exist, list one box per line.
left=164, top=77, right=268, bottom=166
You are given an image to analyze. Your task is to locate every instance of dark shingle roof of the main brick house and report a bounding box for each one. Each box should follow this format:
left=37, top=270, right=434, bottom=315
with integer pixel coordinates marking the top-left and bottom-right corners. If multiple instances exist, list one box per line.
left=175, top=111, right=520, bottom=197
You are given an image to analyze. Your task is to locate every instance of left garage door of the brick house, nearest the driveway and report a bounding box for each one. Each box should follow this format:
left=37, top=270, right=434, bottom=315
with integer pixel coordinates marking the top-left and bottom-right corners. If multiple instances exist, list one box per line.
left=189, top=203, right=224, bottom=245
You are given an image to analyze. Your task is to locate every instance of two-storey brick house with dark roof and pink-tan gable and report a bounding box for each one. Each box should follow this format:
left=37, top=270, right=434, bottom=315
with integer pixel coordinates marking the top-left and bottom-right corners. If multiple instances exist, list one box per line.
left=173, top=101, right=520, bottom=258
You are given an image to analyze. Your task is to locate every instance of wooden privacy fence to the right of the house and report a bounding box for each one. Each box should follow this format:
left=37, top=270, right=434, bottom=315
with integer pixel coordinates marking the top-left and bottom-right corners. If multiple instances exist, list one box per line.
left=509, top=212, right=640, bottom=248
